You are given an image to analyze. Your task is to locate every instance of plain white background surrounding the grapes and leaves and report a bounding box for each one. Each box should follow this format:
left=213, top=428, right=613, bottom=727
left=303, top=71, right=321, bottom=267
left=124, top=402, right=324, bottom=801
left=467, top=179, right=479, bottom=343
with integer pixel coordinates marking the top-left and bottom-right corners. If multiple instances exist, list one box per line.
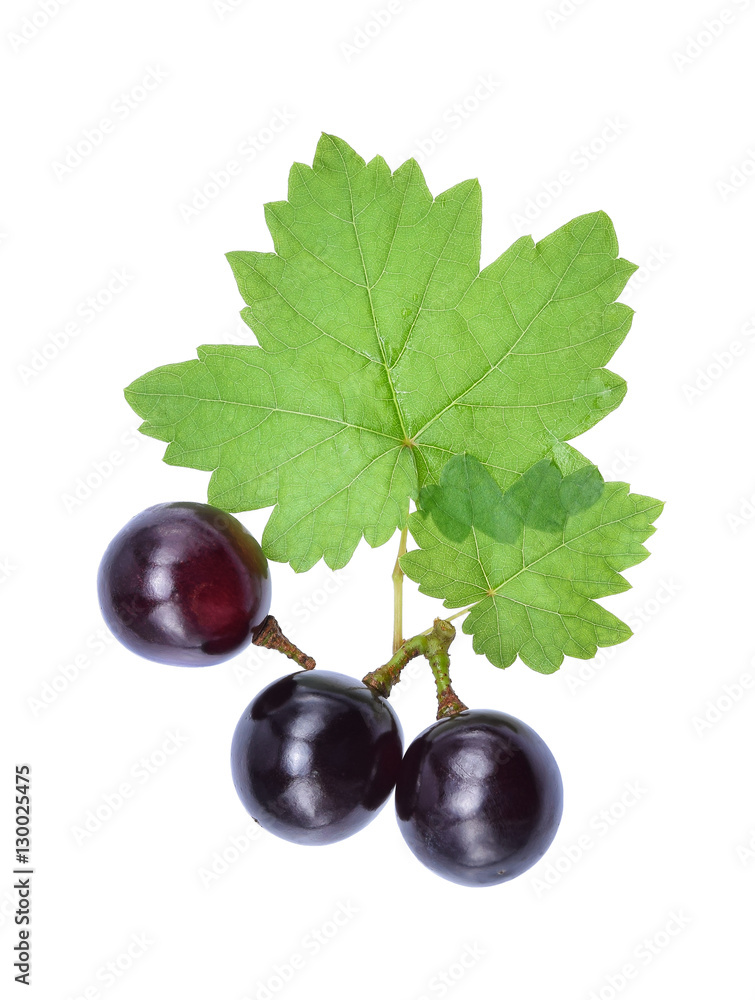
left=0, top=0, right=755, bottom=1000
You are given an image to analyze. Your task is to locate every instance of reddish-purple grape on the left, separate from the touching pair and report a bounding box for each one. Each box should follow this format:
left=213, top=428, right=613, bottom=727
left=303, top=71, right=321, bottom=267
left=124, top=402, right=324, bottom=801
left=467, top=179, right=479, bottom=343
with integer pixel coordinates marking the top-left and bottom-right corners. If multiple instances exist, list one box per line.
left=97, top=502, right=270, bottom=667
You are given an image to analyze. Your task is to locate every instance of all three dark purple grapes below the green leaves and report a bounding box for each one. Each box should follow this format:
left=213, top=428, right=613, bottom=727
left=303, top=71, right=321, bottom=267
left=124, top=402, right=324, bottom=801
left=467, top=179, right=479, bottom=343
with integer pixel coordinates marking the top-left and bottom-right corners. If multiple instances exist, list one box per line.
left=98, top=502, right=563, bottom=886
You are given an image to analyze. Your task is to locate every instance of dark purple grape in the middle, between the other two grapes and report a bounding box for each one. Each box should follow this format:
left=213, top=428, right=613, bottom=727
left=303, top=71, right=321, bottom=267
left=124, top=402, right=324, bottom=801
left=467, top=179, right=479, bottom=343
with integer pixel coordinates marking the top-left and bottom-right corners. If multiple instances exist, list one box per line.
left=231, top=669, right=403, bottom=844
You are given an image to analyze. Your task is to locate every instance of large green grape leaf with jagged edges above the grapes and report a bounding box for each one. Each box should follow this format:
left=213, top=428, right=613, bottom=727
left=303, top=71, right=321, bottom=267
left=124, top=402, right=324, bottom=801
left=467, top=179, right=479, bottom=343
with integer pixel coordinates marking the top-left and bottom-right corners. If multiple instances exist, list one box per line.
left=126, top=135, right=635, bottom=571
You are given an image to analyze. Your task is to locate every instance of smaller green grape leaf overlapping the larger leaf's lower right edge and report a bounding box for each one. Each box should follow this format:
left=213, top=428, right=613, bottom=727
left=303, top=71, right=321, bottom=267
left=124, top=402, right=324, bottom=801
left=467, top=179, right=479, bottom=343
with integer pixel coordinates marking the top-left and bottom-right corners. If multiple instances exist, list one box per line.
left=401, top=455, right=663, bottom=674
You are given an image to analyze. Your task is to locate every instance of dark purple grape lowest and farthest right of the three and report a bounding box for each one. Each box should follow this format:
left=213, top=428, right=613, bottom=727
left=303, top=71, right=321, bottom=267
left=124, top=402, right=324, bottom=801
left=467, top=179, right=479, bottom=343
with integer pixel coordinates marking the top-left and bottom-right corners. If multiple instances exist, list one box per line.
left=396, top=709, right=563, bottom=886
